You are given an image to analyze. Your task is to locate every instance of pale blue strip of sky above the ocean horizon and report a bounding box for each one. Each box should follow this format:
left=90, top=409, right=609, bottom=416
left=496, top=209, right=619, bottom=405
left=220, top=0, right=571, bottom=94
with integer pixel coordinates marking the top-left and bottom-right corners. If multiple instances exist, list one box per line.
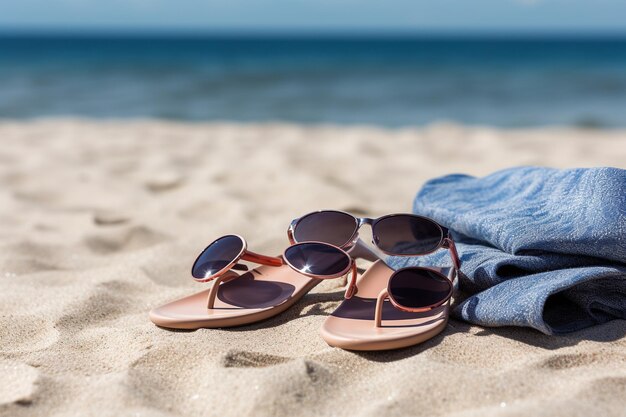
left=0, top=0, right=626, bottom=33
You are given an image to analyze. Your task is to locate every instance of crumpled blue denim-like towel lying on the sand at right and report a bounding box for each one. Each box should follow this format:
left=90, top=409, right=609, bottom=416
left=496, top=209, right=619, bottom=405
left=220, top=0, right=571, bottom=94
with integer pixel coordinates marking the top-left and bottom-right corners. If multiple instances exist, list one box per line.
left=388, top=167, right=626, bottom=334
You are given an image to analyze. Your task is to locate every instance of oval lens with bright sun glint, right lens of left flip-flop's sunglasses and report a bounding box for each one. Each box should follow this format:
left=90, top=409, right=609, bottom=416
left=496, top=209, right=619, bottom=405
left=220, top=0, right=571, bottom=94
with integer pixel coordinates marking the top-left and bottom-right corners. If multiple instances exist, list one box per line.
left=285, top=243, right=350, bottom=276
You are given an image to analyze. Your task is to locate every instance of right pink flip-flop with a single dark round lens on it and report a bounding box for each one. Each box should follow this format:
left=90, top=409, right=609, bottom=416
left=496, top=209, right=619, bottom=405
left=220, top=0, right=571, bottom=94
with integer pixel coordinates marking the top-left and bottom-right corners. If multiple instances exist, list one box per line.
left=320, top=261, right=454, bottom=350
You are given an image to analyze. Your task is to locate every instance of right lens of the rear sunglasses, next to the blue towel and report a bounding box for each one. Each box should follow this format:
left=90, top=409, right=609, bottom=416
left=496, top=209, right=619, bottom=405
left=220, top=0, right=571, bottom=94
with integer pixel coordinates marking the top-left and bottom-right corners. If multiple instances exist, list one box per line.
left=373, top=215, right=443, bottom=255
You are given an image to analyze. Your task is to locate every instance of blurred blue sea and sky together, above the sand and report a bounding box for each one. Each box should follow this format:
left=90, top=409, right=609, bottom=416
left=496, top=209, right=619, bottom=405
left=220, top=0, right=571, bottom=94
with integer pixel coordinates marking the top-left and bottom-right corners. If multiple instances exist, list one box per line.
left=0, top=0, right=626, bottom=128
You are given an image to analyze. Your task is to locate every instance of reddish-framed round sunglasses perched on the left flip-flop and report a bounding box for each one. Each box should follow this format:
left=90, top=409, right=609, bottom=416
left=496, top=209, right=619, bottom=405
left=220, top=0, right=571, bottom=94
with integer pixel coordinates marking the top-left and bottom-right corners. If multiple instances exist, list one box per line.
left=191, top=235, right=357, bottom=297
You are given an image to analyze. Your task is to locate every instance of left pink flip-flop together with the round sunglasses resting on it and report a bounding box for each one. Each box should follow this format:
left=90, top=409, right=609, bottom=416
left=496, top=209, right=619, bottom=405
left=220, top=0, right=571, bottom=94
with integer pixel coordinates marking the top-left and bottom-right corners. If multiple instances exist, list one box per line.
left=150, top=235, right=357, bottom=329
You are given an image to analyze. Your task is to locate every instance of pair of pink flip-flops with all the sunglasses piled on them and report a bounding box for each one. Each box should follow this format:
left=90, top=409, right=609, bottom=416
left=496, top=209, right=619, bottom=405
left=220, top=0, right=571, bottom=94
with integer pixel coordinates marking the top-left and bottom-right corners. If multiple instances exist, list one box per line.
left=150, top=210, right=460, bottom=350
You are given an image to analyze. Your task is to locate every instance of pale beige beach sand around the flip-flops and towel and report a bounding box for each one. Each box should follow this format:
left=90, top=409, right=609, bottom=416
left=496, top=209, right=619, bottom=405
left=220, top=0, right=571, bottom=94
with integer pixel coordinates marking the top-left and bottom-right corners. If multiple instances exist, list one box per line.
left=0, top=119, right=626, bottom=417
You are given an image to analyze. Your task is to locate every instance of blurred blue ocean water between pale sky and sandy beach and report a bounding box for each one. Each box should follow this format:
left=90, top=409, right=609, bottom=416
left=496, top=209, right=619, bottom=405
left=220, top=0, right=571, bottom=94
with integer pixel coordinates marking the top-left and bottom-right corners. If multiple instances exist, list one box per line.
left=0, top=33, right=626, bottom=128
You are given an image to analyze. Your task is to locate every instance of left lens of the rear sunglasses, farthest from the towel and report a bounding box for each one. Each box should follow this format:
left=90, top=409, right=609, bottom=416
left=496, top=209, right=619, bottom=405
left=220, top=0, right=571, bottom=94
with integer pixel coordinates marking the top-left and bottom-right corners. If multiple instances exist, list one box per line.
left=293, top=211, right=357, bottom=246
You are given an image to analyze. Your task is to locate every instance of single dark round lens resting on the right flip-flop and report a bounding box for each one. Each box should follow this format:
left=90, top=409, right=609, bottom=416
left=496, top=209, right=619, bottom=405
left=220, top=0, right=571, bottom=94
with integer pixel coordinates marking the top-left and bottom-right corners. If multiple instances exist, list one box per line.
left=389, top=268, right=452, bottom=308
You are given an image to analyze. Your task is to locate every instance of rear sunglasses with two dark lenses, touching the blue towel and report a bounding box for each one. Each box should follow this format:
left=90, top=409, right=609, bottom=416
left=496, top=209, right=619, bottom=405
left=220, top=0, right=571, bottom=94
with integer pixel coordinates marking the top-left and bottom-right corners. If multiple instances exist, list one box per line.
left=287, top=210, right=460, bottom=271
